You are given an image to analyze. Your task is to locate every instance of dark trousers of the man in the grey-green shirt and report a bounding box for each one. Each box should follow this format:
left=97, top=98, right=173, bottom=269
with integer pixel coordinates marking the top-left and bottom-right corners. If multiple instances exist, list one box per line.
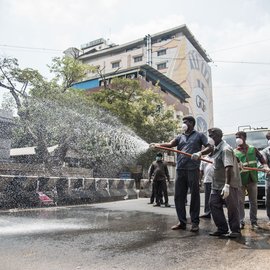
left=210, top=187, right=240, bottom=233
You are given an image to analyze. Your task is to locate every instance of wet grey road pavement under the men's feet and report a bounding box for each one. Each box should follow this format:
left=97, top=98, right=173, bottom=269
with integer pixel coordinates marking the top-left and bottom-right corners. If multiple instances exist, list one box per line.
left=0, top=197, right=270, bottom=270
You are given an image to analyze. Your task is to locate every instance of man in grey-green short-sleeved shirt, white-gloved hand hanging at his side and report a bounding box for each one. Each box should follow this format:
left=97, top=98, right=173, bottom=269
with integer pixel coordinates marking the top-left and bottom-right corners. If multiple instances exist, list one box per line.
left=208, top=128, right=241, bottom=238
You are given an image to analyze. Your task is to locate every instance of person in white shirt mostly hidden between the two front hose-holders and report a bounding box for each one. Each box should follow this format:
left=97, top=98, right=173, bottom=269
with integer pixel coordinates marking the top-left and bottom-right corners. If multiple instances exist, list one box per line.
left=200, top=154, right=214, bottom=218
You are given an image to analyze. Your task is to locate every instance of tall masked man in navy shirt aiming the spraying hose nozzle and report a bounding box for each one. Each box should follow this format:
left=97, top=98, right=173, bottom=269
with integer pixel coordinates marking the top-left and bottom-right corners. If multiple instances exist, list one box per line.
left=150, top=116, right=212, bottom=232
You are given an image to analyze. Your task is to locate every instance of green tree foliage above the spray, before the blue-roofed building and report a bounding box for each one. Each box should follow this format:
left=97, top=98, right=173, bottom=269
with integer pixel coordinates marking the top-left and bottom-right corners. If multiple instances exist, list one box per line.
left=91, top=78, right=178, bottom=143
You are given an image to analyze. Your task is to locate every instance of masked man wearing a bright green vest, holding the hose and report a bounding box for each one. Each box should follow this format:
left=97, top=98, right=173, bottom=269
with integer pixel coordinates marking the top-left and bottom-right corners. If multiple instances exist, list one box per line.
left=234, top=131, right=268, bottom=230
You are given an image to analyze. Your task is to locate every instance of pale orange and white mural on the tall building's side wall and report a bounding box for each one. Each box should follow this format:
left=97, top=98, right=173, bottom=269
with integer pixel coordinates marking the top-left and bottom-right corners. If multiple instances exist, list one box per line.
left=160, top=37, right=213, bottom=133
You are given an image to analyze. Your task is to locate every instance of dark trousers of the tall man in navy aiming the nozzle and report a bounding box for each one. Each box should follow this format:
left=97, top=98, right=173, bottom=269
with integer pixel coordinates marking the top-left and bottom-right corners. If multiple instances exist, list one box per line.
left=174, top=169, right=200, bottom=224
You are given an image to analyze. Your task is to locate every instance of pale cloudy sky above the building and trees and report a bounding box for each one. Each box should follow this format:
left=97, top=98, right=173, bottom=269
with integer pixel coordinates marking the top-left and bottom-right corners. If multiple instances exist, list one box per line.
left=0, top=0, right=270, bottom=133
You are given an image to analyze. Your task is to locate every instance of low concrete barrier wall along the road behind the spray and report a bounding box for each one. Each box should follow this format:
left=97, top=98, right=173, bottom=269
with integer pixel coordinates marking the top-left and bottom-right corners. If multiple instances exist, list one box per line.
left=0, top=175, right=137, bottom=208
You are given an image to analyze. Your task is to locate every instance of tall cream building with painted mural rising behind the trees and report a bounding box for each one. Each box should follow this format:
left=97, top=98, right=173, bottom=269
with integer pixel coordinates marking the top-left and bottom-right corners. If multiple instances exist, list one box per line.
left=71, top=25, right=213, bottom=132
